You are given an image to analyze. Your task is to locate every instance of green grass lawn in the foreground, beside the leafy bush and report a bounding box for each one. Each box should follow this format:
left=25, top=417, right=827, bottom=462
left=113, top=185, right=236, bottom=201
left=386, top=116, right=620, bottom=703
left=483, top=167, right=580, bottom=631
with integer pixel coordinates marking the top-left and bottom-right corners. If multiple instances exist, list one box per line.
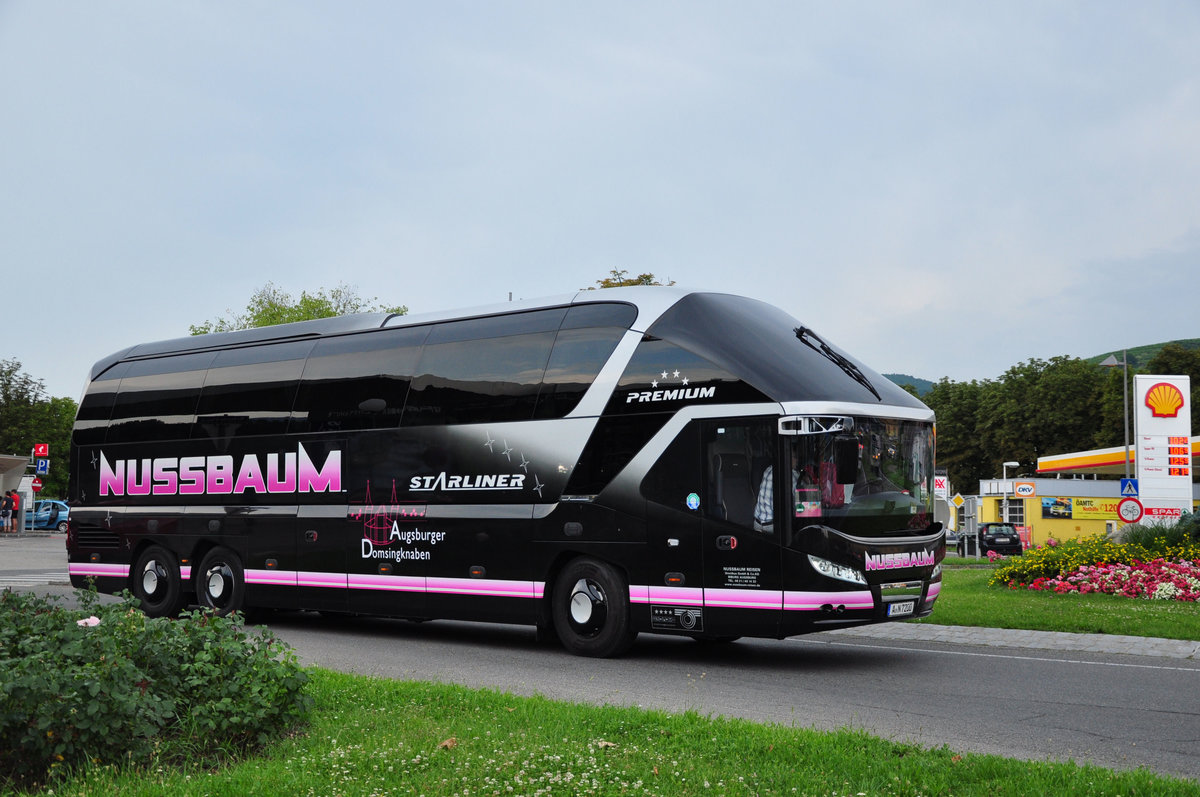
left=37, top=670, right=1200, bottom=797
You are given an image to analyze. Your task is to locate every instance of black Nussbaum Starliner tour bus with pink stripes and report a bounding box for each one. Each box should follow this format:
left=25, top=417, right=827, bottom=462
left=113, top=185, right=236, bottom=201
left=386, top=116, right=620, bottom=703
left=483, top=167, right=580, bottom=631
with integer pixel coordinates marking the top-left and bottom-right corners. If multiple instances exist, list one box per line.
left=67, top=287, right=946, bottom=655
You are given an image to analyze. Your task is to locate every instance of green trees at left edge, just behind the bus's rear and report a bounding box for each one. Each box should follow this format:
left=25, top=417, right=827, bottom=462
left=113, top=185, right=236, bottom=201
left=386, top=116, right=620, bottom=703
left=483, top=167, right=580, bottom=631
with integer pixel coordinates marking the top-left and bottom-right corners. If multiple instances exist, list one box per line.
left=0, top=360, right=77, bottom=497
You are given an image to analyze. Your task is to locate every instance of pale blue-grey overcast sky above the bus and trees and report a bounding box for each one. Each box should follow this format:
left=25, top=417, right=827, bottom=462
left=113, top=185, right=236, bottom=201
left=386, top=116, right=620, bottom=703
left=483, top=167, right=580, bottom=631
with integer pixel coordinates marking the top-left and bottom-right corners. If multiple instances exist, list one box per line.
left=0, top=0, right=1200, bottom=399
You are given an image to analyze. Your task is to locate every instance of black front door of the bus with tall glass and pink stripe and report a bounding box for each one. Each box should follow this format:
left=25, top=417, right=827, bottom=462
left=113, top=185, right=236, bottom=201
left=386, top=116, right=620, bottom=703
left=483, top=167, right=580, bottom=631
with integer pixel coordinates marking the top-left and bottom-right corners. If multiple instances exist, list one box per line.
left=701, top=418, right=790, bottom=636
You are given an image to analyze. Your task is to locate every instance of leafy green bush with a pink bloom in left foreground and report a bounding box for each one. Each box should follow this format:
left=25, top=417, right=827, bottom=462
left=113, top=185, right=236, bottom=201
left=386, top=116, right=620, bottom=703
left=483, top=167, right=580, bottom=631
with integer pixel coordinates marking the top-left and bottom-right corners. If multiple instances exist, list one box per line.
left=0, top=591, right=311, bottom=787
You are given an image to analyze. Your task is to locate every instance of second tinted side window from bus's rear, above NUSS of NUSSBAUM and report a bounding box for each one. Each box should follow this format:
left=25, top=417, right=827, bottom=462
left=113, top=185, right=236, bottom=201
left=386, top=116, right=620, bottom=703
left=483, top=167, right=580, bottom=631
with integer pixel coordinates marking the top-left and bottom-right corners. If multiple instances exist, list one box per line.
left=104, top=352, right=215, bottom=443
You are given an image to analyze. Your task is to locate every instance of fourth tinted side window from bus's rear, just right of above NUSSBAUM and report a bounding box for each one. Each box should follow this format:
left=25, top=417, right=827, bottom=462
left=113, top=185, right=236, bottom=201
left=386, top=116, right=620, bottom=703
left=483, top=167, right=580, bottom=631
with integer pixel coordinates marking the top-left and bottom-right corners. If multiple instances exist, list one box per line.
left=290, top=326, right=430, bottom=432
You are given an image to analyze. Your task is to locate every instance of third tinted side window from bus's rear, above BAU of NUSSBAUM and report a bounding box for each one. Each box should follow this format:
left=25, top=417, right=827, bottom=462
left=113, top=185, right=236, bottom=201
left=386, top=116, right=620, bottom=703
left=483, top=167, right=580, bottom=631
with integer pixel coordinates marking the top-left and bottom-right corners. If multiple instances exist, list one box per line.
left=192, top=341, right=313, bottom=438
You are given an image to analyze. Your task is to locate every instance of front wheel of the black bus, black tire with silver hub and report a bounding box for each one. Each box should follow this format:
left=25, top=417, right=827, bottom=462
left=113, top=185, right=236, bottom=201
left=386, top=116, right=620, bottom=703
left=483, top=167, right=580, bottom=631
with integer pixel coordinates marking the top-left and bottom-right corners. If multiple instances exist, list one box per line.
left=551, top=558, right=637, bottom=658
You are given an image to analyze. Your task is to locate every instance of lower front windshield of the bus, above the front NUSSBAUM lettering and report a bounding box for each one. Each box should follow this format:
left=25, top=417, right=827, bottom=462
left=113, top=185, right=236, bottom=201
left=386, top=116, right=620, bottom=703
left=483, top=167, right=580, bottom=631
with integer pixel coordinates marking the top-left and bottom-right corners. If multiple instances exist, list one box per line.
left=781, top=418, right=934, bottom=537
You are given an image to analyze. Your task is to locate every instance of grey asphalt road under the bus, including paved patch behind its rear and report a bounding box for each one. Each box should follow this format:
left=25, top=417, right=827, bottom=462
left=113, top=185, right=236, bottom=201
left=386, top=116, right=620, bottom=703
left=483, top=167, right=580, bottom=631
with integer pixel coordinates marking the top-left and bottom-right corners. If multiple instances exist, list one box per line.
left=9, top=535, right=1200, bottom=780
